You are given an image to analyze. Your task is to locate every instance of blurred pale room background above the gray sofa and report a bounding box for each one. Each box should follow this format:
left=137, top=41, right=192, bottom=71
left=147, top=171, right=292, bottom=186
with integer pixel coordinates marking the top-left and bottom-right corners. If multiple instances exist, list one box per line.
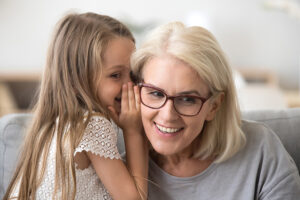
left=0, top=0, right=300, bottom=116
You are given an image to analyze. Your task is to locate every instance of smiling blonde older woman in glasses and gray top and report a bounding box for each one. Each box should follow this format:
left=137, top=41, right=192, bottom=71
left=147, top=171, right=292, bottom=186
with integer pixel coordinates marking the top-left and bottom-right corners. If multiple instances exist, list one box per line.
left=132, top=23, right=300, bottom=200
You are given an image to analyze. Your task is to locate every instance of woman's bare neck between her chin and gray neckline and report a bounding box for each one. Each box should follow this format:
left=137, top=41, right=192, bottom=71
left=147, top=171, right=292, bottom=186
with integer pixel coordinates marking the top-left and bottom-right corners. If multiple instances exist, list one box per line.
left=151, top=152, right=213, bottom=177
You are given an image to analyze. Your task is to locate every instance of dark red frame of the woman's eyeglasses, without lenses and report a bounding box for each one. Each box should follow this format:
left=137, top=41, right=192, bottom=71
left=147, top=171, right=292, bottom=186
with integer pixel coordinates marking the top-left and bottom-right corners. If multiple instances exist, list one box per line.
left=138, top=83, right=211, bottom=117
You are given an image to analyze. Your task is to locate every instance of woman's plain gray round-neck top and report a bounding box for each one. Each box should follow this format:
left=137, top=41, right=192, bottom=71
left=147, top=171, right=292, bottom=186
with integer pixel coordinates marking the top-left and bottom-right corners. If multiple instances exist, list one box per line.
left=148, top=121, right=300, bottom=200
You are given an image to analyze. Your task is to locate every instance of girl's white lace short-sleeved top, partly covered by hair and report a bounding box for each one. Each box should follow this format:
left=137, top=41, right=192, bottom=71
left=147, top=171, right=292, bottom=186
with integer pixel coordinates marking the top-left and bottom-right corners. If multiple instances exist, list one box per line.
left=12, top=116, right=121, bottom=200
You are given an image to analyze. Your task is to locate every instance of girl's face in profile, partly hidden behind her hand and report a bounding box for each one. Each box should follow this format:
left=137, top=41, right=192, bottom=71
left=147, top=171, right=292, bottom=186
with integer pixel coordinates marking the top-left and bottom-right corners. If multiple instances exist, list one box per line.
left=98, top=37, right=135, bottom=113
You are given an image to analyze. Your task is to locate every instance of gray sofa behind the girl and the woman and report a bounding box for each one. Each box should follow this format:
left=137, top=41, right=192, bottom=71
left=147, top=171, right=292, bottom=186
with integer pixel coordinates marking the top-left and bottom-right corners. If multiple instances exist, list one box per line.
left=0, top=108, right=300, bottom=199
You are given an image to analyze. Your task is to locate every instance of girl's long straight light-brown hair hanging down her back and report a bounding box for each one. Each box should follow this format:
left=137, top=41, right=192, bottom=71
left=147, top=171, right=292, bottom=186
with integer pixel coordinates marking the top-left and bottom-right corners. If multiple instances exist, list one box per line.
left=4, top=13, right=134, bottom=199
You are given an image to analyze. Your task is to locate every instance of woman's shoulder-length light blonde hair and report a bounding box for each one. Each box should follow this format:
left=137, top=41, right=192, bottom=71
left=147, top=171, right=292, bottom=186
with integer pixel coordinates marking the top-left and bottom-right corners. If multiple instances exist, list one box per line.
left=131, top=22, right=246, bottom=162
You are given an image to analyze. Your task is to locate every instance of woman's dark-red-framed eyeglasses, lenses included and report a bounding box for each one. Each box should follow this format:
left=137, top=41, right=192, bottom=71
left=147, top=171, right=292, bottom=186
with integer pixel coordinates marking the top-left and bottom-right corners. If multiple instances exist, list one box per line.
left=138, top=83, right=209, bottom=116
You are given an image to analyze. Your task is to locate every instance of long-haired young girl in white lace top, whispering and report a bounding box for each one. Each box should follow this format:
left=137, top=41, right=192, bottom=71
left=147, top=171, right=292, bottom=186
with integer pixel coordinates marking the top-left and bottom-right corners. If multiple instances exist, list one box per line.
left=4, top=13, right=148, bottom=200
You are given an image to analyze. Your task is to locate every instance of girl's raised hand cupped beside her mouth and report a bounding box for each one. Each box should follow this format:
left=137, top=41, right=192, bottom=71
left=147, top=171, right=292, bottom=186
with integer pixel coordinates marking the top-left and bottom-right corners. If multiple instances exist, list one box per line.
left=108, top=82, right=143, bottom=133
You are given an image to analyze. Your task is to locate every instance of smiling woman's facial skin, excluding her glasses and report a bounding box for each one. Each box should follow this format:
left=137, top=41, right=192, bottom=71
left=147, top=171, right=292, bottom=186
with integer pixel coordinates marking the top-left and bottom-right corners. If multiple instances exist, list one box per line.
left=141, top=56, right=214, bottom=156
